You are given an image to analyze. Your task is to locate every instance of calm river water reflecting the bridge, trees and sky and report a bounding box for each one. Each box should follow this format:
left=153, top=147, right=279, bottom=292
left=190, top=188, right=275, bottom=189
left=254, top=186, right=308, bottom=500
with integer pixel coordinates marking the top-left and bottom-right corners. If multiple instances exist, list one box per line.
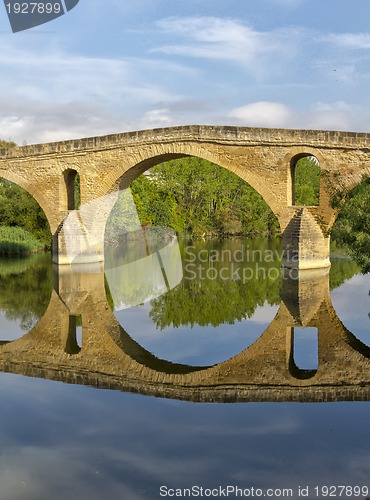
left=0, top=241, right=370, bottom=500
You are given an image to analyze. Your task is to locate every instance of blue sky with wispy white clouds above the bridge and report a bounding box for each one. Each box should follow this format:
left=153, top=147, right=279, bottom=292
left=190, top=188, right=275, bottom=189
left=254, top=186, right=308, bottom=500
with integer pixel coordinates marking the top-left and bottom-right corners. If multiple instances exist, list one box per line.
left=0, top=0, right=370, bottom=145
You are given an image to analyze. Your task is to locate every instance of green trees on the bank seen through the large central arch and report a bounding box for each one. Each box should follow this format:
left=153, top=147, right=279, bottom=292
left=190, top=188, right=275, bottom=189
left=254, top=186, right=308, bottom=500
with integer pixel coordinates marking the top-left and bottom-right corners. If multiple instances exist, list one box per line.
left=125, top=157, right=279, bottom=237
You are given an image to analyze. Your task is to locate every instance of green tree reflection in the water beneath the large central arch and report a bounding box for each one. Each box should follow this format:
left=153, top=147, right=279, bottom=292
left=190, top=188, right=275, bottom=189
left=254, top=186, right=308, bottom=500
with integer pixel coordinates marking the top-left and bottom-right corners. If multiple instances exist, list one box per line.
left=146, top=238, right=281, bottom=330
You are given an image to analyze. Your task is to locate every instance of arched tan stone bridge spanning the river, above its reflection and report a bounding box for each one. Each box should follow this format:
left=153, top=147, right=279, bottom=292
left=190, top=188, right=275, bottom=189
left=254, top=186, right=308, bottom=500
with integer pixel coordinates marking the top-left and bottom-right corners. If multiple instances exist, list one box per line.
left=0, top=126, right=370, bottom=269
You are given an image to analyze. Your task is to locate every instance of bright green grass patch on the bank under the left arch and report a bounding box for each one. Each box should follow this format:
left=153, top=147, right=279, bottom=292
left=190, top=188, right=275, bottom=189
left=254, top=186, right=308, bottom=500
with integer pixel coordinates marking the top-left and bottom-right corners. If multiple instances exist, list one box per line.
left=0, top=226, right=45, bottom=255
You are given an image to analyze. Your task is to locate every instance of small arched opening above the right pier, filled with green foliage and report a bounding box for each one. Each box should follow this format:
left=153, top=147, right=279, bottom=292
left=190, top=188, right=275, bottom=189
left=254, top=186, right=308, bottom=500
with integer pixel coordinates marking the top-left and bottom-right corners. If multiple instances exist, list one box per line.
left=290, top=153, right=321, bottom=206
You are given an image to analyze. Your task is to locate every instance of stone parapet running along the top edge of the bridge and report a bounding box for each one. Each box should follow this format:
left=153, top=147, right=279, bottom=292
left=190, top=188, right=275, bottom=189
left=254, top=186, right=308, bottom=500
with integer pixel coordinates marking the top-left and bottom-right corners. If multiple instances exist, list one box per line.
left=0, top=125, right=370, bottom=158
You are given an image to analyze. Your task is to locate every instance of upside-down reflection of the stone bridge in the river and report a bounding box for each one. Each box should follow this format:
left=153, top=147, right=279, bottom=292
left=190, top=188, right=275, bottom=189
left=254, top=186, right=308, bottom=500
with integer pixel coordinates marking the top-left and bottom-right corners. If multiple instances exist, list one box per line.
left=0, top=264, right=370, bottom=402
